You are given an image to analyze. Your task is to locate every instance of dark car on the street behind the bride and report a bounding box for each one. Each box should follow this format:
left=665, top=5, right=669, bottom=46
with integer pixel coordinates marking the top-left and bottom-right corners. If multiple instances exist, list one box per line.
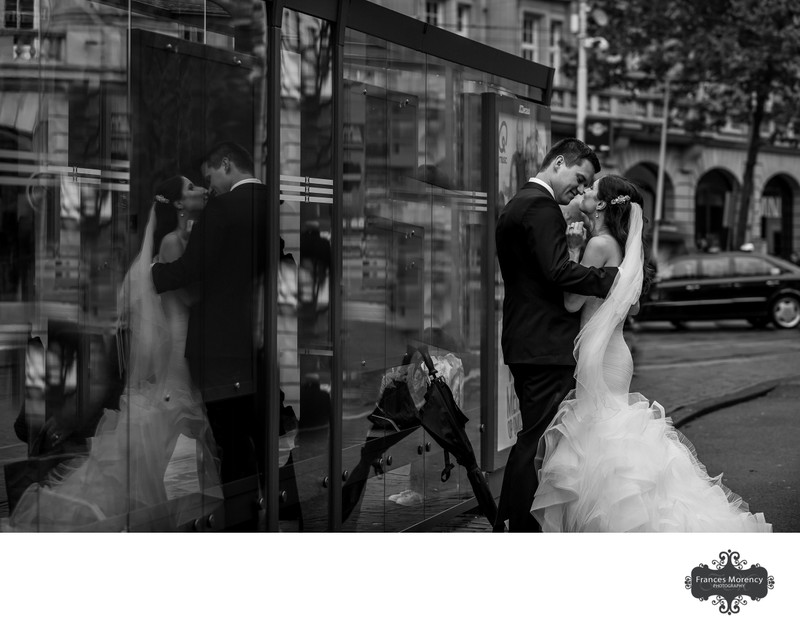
left=636, top=252, right=800, bottom=329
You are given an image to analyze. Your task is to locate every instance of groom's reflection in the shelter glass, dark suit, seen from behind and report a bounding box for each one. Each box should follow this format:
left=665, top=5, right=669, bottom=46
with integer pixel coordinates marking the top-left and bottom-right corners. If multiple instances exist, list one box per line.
left=152, top=142, right=267, bottom=498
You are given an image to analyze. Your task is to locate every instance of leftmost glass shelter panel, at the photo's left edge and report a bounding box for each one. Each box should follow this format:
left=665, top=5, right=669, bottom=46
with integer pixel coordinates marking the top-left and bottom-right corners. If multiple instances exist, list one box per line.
left=0, top=2, right=136, bottom=530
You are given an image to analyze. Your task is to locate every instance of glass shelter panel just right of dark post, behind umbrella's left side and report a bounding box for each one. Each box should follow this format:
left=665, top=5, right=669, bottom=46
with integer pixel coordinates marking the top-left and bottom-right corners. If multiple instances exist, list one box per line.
left=342, top=31, right=429, bottom=530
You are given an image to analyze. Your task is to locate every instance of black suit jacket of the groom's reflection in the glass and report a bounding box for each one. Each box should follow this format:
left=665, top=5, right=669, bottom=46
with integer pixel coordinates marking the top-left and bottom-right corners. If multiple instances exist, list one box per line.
left=152, top=183, right=267, bottom=401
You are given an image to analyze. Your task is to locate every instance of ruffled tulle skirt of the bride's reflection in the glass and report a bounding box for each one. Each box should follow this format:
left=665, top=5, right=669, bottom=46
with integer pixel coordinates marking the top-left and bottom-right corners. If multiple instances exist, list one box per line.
left=3, top=386, right=222, bottom=532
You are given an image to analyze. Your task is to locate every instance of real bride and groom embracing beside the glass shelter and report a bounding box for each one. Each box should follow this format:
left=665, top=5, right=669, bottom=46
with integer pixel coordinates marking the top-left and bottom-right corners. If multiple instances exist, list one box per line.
left=494, top=138, right=772, bottom=532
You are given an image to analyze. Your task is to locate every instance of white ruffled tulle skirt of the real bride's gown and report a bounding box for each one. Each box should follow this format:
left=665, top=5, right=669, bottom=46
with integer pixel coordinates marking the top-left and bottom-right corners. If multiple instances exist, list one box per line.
left=531, top=393, right=772, bottom=532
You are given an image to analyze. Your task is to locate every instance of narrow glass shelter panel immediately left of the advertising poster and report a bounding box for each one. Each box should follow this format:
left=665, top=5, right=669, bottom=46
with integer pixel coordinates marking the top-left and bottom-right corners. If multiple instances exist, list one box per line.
left=418, top=57, right=487, bottom=517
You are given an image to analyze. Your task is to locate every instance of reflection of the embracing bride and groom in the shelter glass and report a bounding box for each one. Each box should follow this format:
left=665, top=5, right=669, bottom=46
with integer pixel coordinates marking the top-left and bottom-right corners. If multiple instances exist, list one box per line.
left=2, top=142, right=268, bottom=531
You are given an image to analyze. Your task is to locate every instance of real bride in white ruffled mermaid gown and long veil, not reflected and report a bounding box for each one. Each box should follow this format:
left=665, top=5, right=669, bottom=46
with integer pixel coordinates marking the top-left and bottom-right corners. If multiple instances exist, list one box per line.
left=531, top=175, right=772, bottom=532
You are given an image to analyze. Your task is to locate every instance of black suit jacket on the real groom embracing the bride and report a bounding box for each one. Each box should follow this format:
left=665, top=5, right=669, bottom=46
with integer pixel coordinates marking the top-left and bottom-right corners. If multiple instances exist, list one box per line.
left=495, top=182, right=616, bottom=365
